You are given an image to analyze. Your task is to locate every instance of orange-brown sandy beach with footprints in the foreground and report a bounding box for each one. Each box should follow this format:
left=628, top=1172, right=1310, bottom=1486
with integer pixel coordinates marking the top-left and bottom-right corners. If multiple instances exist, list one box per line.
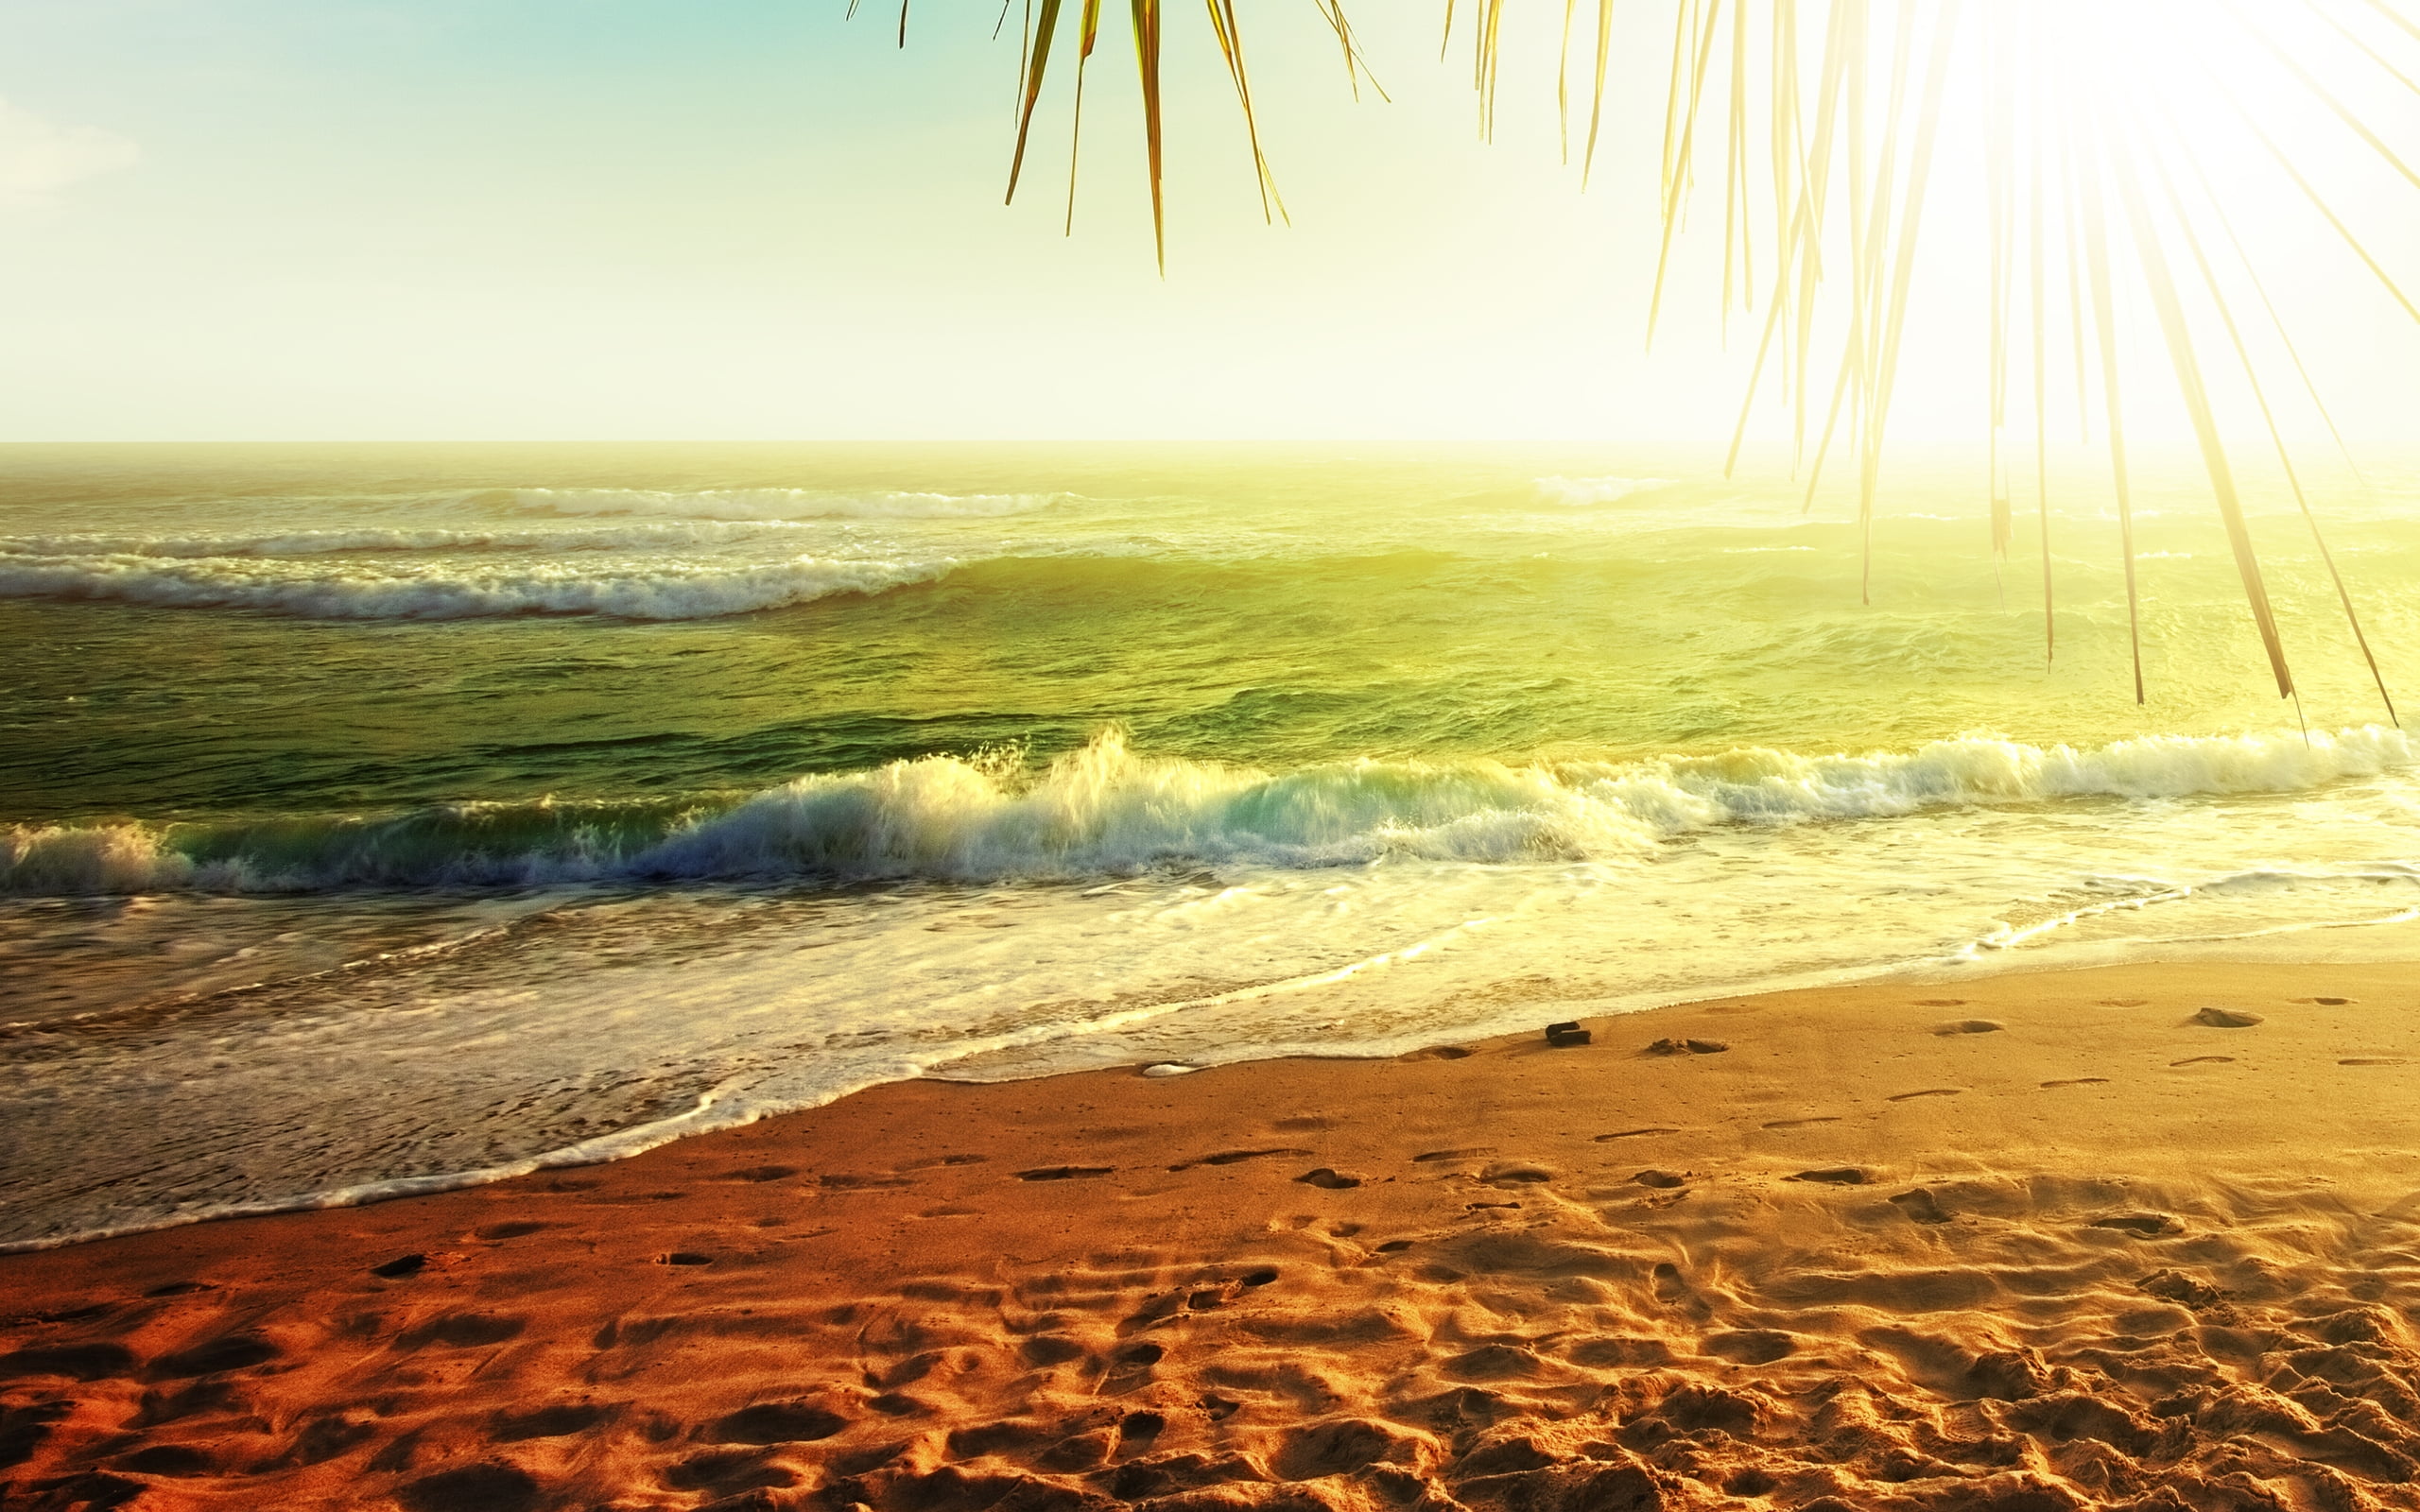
left=0, top=965, right=2420, bottom=1512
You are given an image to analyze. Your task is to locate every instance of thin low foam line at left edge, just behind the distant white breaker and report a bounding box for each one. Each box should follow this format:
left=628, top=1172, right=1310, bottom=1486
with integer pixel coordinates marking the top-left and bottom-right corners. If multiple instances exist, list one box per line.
left=0, top=520, right=822, bottom=558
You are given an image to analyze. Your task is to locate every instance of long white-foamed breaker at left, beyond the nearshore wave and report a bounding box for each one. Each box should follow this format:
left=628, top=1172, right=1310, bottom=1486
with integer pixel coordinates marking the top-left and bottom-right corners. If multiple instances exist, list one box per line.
left=0, top=557, right=949, bottom=619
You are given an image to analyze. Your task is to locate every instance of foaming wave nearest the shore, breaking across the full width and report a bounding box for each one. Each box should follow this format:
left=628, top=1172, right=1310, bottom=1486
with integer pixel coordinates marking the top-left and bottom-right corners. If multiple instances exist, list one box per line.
left=0, top=726, right=2412, bottom=893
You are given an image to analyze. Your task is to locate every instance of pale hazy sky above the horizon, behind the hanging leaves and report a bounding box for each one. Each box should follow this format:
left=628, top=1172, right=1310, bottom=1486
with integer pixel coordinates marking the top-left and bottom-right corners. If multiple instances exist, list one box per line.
left=0, top=0, right=2420, bottom=455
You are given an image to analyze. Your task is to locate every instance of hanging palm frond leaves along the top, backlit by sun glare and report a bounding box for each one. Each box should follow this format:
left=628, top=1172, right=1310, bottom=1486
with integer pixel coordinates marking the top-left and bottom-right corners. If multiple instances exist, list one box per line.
left=880, top=0, right=2420, bottom=716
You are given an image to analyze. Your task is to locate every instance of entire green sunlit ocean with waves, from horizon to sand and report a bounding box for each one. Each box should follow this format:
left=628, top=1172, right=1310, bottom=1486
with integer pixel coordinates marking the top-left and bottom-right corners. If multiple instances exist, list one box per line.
left=0, top=445, right=2420, bottom=1246
